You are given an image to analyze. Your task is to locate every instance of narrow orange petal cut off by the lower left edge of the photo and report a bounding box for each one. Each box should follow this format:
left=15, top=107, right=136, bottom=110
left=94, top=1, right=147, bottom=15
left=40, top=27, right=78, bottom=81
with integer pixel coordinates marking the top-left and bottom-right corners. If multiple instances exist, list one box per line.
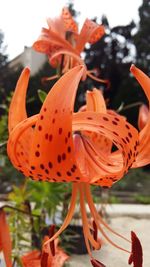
left=0, top=209, right=12, bottom=267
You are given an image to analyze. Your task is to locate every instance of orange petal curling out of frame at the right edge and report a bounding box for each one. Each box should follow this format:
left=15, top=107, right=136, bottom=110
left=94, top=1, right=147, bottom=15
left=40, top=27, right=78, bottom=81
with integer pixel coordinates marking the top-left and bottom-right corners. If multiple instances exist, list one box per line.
left=130, top=65, right=150, bottom=168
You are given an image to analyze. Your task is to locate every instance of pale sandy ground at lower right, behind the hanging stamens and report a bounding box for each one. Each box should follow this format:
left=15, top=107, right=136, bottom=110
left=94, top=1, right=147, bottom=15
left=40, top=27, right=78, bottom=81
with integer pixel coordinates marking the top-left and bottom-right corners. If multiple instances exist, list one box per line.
left=68, top=216, right=150, bottom=267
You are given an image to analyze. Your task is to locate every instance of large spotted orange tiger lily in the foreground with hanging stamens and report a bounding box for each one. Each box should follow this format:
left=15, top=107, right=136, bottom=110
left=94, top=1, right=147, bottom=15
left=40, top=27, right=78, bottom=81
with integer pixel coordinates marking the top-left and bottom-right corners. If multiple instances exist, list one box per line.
left=7, top=66, right=150, bottom=266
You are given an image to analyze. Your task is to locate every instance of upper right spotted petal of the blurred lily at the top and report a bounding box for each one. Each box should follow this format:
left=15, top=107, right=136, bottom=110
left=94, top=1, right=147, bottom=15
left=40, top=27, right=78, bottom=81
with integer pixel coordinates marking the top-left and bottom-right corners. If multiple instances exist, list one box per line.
left=76, top=19, right=105, bottom=52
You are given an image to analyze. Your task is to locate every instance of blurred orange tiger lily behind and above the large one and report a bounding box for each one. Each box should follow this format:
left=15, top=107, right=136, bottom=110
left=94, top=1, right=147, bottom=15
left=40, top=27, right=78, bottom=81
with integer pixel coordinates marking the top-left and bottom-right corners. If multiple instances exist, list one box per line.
left=33, top=8, right=108, bottom=83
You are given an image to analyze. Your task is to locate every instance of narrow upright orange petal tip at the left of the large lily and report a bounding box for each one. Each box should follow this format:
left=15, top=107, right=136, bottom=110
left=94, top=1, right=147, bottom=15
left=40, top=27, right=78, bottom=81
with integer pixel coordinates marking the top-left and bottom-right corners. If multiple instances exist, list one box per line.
left=8, top=68, right=30, bottom=132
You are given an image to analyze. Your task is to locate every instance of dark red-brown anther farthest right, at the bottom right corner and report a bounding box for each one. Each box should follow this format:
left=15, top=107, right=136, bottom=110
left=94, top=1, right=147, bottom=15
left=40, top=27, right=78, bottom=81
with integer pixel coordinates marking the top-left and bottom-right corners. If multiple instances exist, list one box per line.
left=128, top=231, right=143, bottom=267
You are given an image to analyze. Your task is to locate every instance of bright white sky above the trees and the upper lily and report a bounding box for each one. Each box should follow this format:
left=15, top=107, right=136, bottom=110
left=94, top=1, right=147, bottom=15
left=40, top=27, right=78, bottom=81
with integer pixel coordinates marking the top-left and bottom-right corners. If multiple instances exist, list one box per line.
left=0, top=0, right=142, bottom=59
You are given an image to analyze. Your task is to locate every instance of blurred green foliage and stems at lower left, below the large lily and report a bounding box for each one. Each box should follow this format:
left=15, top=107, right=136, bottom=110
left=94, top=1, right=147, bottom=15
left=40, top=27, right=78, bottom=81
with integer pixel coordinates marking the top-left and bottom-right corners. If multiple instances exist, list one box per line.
left=4, top=179, right=71, bottom=267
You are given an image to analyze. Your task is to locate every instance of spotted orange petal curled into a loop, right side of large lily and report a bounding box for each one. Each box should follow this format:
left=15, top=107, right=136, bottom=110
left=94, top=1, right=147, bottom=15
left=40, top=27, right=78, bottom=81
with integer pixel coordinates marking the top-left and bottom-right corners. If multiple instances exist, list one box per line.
left=73, top=112, right=138, bottom=186
